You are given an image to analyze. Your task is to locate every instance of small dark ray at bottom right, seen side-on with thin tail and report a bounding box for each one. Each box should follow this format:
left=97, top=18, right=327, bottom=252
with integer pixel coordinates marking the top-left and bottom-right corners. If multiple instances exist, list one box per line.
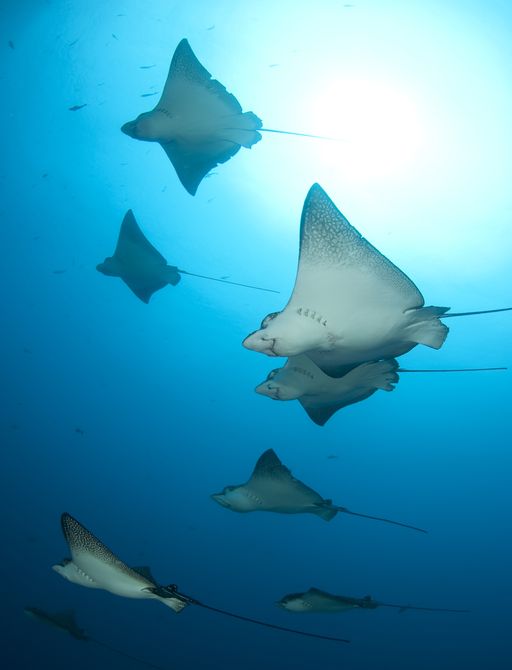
left=276, top=588, right=469, bottom=613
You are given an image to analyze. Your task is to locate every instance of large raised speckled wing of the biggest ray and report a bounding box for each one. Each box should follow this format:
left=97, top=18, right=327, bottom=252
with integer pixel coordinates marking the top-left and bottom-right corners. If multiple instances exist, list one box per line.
left=290, top=184, right=424, bottom=326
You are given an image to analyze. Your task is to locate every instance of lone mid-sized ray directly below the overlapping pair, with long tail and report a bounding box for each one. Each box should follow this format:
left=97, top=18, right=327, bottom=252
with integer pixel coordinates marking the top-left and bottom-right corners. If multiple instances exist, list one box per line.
left=211, top=449, right=427, bottom=533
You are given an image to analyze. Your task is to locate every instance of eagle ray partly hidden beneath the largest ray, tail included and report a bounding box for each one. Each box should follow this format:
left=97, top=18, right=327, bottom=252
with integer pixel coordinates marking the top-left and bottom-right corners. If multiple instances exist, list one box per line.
left=255, top=354, right=506, bottom=426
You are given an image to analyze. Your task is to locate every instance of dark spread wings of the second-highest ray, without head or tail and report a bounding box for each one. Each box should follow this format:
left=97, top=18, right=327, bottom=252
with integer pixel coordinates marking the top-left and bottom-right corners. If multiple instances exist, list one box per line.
left=114, top=209, right=176, bottom=303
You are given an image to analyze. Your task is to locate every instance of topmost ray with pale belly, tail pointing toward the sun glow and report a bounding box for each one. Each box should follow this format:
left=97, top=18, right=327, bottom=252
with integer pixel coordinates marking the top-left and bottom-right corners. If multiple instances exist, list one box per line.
left=121, top=39, right=336, bottom=195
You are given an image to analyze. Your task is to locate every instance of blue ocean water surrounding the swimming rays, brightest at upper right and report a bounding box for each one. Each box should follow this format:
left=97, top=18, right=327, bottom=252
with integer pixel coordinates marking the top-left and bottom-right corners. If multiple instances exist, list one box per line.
left=0, top=0, right=512, bottom=670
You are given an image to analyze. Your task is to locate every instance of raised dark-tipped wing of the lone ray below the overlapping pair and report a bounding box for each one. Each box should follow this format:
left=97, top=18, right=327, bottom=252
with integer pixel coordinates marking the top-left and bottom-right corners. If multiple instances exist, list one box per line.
left=245, top=449, right=323, bottom=516
